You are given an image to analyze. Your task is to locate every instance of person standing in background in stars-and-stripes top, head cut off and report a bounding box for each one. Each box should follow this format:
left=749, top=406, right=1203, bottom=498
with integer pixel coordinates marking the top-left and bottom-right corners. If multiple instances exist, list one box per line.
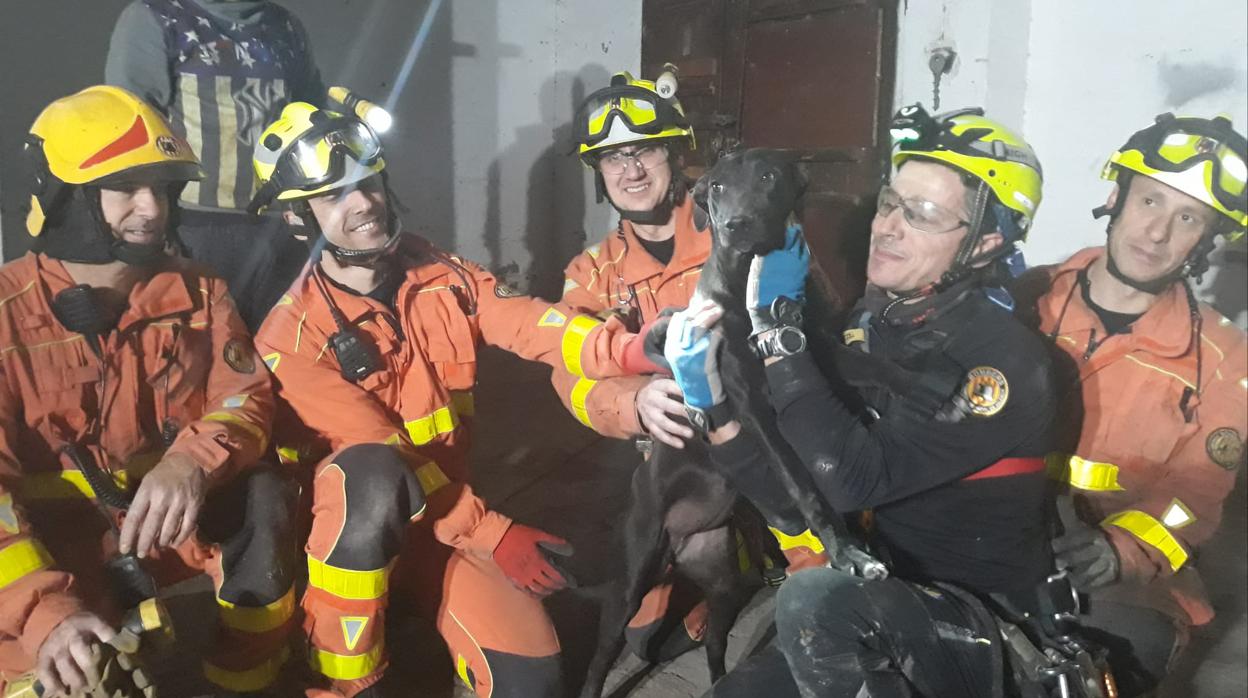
left=105, top=0, right=326, bottom=331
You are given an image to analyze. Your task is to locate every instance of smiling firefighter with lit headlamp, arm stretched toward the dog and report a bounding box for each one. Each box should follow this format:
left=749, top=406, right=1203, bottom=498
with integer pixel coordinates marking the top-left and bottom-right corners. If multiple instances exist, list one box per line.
left=255, top=102, right=643, bottom=696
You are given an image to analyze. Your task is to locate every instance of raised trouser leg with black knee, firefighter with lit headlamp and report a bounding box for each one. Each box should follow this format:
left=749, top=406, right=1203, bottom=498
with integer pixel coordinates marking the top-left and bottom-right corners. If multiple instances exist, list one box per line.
left=302, top=445, right=424, bottom=696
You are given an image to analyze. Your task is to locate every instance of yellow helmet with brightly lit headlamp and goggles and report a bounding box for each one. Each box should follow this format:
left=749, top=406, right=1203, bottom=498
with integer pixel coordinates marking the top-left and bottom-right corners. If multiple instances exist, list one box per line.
left=248, top=102, right=386, bottom=212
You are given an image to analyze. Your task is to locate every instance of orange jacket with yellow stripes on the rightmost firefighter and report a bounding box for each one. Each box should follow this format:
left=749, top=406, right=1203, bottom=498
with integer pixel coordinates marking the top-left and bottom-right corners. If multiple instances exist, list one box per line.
left=1020, top=247, right=1248, bottom=624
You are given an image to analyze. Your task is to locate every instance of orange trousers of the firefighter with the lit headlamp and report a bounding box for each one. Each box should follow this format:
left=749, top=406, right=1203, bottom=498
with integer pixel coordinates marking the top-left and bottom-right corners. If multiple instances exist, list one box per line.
left=303, top=445, right=560, bottom=698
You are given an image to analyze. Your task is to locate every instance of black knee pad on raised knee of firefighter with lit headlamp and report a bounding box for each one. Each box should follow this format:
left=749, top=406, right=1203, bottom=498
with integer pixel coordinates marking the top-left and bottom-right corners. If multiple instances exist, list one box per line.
left=326, top=443, right=424, bottom=569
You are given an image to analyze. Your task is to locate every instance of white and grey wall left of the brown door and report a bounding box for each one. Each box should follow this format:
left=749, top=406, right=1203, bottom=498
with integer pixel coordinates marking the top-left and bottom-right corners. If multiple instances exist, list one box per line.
left=0, top=0, right=641, bottom=300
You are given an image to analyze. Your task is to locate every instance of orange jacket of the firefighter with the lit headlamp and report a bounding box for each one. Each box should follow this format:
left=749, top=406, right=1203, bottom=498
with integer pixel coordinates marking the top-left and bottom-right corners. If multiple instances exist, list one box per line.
left=256, top=235, right=633, bottom=557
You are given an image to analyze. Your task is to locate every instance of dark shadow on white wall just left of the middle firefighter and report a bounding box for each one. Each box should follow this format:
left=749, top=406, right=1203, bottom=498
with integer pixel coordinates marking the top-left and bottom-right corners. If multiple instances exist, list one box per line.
left=484, top=65, right=609, bottom=300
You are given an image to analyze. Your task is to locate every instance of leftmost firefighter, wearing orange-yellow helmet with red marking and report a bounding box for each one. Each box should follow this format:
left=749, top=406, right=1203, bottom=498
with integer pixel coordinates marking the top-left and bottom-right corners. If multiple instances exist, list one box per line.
left=0, top=86, right=297, bottom=696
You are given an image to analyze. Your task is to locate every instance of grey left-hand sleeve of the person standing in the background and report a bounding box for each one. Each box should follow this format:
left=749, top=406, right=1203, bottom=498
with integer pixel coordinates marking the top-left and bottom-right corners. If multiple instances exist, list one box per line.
left=104, top=0, right=173, bottom=116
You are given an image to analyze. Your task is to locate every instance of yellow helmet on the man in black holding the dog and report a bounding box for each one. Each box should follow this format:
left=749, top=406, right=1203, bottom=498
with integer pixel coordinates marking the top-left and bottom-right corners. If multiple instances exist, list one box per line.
left=891, top=104, right=1043, bottom=240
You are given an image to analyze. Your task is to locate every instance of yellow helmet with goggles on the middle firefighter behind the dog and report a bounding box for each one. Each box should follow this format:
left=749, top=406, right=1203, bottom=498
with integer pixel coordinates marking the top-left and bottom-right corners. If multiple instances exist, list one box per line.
left=573, top=66, right=696, bottom=166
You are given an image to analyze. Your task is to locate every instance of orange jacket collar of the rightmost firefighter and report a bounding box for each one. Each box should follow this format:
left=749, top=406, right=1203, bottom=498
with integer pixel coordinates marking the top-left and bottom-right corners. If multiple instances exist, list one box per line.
left=1042, top=247, right=1192, bottom=358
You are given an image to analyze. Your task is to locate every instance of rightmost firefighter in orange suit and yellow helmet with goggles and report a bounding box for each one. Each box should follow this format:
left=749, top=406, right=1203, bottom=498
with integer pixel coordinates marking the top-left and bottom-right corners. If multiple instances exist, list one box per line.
left=1021, top=114, right=1248, bottom=696
